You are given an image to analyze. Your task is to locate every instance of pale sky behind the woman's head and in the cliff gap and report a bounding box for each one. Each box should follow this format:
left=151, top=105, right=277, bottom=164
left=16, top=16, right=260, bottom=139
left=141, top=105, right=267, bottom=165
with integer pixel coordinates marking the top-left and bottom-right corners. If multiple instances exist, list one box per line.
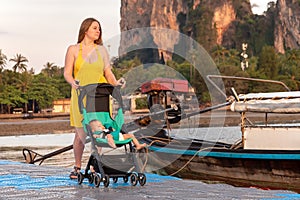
left=0, top=0, right=271, bottom=73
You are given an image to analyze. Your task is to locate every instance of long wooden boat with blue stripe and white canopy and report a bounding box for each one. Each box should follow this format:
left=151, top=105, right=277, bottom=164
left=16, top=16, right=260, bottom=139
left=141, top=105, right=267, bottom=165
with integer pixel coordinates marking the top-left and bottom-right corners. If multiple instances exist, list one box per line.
left=136, top=88, right=300, bottom=193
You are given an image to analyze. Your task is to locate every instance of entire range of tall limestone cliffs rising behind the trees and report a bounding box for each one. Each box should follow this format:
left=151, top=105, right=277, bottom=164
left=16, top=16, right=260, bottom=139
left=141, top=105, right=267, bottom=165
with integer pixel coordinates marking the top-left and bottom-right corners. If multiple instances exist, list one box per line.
left=119, top=0, right=300, bottom=60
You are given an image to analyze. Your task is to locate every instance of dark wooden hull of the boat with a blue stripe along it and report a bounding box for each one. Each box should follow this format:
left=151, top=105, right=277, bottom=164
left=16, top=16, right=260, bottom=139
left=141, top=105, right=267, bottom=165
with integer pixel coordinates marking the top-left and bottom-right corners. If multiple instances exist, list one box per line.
left=141, top=130, right=300, bottom=193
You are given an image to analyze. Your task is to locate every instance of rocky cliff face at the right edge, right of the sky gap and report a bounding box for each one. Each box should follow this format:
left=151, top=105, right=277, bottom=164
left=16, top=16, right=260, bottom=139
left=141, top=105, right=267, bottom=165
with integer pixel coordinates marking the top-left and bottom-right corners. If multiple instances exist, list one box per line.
left=274, top=0, right=300, bottom=53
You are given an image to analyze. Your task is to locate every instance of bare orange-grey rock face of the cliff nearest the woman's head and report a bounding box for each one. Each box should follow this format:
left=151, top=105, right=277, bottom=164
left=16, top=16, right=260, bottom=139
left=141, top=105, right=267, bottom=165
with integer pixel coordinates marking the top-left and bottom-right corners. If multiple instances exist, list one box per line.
left=119, top=0, right=187, bottom=59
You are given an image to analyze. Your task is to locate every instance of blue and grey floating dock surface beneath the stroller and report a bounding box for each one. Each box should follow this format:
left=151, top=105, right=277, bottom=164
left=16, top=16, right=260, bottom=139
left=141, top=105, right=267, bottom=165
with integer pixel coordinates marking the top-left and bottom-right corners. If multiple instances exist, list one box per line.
left=0, top=160, right=300, bottom=200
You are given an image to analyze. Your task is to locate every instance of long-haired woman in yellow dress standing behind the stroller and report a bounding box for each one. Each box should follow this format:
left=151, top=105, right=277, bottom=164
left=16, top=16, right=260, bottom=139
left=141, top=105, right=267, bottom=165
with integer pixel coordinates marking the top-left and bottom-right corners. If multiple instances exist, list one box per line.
left=64, top=18, right=124, bottom=179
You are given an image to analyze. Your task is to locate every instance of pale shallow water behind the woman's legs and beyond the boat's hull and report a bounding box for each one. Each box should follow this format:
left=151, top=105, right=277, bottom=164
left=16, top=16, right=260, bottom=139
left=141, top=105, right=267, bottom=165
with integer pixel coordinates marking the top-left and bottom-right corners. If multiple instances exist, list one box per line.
left=0, top=127, right=240, bottom=168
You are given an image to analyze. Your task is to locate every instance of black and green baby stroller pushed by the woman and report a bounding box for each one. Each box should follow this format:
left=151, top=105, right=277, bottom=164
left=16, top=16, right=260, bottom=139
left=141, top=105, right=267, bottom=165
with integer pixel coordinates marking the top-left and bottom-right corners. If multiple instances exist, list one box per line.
left=77, top=83, right=146, bottom=187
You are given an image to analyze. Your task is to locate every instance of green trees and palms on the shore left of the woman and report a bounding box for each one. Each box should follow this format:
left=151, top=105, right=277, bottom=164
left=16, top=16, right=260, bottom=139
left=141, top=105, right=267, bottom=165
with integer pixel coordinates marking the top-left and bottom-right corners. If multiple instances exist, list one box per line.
left=0, top=49, right=71, bottom=113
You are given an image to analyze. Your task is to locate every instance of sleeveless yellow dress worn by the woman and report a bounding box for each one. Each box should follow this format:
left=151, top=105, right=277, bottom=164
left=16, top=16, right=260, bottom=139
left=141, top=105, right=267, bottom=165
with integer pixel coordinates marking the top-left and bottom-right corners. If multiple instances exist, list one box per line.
left=70, top=43, right=107, bottom=127
